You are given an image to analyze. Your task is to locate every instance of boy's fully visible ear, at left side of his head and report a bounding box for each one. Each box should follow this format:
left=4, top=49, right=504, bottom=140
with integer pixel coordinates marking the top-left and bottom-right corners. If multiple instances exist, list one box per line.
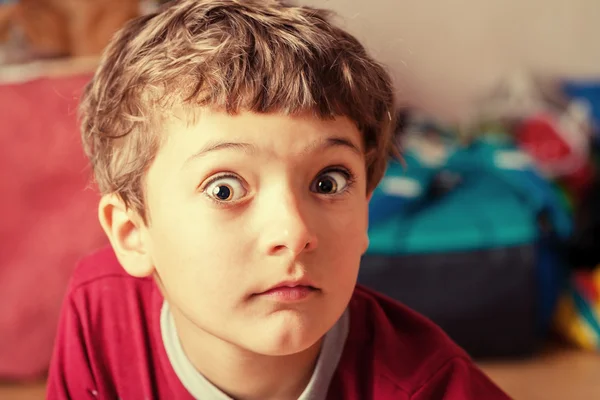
left=98, top=194, right=154, bottom=278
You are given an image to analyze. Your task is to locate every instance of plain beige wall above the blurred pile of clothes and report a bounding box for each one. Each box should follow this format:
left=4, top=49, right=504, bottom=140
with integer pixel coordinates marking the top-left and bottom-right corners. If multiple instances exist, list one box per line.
left=298, top=0, right=600, bottom=118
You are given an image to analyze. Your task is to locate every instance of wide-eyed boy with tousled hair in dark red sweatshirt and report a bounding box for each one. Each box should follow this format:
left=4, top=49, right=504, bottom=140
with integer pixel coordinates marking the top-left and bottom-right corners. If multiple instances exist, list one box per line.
left=48, top=0, right=506, bottom=400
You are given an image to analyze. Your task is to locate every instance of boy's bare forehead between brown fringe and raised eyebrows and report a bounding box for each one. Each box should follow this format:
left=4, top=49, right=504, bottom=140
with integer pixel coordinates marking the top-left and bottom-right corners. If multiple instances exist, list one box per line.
left=158, top=109, right=364, bottom=162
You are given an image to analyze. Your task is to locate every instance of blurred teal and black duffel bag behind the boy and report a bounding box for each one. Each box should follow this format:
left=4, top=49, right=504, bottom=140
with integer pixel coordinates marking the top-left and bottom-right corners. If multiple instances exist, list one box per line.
left=359, top=137, right=571, bottom=357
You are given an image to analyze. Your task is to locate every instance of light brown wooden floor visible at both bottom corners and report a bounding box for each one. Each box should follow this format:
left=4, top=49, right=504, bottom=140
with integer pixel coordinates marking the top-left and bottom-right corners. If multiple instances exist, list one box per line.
left=0, top=345, right=600, bottom=400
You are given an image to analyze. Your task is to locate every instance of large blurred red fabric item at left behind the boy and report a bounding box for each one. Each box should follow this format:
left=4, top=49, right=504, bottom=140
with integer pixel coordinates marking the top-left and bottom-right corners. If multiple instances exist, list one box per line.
left=0, top=76, right=107, bottom=379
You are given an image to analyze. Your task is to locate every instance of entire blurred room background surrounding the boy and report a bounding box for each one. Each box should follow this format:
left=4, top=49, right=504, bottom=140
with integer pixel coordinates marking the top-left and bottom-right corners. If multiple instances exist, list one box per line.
left=0, top=0, right=600, bottom=400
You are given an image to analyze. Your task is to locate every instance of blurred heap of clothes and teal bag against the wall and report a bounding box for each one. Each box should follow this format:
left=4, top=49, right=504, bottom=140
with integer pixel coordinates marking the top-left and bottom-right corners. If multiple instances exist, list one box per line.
left=359, top=75, right=600, bottom=358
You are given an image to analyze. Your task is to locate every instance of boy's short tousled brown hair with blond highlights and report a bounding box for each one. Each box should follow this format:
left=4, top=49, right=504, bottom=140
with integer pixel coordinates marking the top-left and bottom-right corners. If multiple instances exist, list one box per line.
left=80, top=0, right=395, bottom=222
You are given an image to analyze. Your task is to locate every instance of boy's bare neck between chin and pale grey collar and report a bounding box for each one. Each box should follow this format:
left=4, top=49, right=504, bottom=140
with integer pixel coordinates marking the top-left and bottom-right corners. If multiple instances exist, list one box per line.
left=173, top=310, right=322, bottom=400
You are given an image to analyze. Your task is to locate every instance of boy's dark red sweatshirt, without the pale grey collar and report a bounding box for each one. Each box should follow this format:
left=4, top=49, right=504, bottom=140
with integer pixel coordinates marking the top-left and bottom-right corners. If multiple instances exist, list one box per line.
left=47, top=249, right=508, bottom=400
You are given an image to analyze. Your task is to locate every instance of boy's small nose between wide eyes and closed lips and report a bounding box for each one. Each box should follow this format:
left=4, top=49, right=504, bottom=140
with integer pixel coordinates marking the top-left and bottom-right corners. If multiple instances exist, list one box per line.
left=262, top=191, right=318, bottom=257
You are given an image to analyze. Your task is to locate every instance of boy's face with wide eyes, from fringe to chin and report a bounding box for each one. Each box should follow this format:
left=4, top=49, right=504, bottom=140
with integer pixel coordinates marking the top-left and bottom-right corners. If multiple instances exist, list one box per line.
left=142, top=110, right=368, bottom=355
